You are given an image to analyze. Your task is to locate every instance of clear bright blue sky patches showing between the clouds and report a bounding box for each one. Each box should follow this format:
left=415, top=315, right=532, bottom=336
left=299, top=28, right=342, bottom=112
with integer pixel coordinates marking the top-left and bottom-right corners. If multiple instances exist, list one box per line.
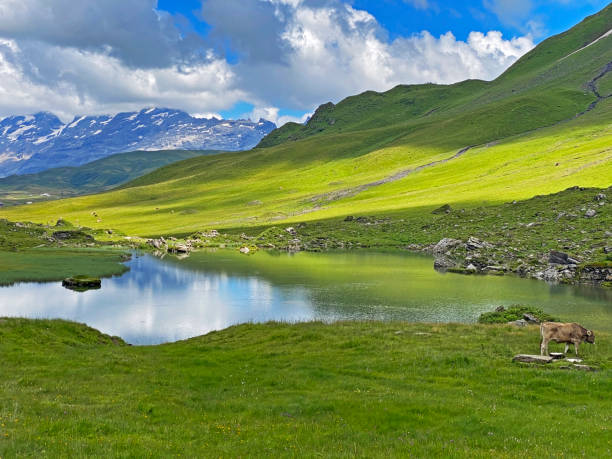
left=158, top=0, right=609, bottom=118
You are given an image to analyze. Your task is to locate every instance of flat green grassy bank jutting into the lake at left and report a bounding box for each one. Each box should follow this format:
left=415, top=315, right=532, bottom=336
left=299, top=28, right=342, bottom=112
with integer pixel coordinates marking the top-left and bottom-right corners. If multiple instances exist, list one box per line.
left=0, top=248, right=127, bottom=286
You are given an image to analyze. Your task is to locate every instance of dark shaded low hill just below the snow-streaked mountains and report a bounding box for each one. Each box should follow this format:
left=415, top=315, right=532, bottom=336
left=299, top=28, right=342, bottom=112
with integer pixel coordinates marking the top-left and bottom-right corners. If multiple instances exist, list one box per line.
left=0, top=150, right=218, bottom=205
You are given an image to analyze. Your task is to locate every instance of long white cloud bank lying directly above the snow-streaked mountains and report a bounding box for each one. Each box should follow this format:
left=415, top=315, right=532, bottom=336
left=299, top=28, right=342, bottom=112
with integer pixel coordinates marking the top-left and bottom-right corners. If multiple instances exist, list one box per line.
left=0, top=40, right=246, bottom=119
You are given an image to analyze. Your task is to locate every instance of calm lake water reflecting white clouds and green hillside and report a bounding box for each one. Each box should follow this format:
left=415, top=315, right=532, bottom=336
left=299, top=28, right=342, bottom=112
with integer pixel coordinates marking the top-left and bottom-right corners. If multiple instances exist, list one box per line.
left=0, top=251, right=612, bottom=344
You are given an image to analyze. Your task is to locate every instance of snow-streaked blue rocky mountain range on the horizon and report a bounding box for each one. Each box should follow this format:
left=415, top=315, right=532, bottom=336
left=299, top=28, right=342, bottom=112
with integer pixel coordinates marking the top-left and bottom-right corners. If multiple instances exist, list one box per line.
left=0, top=108, right=276, bottom=177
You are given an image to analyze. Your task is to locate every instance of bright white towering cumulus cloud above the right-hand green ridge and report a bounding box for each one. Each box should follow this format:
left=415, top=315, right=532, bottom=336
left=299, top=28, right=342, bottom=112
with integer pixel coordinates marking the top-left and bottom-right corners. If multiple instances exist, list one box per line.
left=218, top=2, right=533, bottom=109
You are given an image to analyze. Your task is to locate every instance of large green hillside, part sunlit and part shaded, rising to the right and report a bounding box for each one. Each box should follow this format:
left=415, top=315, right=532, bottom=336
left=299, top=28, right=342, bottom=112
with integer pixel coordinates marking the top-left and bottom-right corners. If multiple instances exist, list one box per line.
left=0, top=5, right=612, bottom=235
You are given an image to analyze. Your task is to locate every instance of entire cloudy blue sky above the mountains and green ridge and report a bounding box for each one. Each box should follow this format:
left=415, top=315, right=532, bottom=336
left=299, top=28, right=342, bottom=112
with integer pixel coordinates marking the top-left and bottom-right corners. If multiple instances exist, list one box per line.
left=0, top=0, right=608, bottom=124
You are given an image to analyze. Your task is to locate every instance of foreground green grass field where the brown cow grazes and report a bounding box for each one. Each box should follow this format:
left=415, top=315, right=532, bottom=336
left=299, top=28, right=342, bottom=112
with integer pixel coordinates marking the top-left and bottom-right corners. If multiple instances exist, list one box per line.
left=0, top=319, right=612, bottom=457
